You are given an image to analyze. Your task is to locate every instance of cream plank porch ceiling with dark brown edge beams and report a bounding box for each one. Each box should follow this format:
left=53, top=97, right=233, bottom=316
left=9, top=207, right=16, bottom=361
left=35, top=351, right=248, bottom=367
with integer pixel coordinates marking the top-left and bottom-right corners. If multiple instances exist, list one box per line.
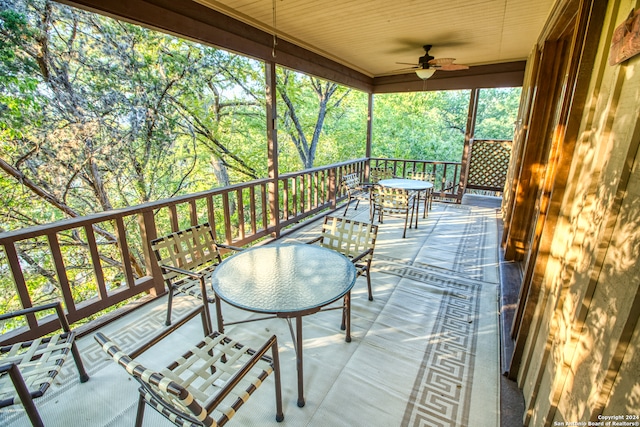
left=57, top=0, right=554, bottom=93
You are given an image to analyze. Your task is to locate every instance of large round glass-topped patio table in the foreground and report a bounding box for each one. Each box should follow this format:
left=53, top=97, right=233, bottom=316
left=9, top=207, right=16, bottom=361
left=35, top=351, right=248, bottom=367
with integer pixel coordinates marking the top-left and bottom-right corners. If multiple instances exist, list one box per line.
left=211, top=244, right=356, bottom=407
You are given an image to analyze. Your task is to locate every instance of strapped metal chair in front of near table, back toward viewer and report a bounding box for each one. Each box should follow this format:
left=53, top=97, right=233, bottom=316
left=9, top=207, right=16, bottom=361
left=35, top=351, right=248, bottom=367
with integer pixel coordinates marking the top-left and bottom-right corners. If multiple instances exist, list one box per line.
left=94, top=306, right=284, bottom=427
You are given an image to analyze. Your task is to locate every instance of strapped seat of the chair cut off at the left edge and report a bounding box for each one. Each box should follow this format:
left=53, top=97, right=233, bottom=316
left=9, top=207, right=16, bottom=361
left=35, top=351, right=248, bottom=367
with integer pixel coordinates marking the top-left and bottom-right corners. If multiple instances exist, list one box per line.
left=0, top=332, right=74, bottom=407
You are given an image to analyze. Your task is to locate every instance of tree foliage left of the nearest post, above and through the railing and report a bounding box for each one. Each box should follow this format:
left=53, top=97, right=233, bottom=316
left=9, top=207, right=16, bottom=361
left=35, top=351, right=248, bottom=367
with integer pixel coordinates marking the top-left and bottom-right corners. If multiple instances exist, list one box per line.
left=0, top=0, right=266, bottom=314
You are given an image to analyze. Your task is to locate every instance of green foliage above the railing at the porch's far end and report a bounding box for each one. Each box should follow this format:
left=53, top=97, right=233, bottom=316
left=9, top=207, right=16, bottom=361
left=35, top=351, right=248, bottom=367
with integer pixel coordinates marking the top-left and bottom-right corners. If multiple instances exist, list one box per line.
left=372, top=88, right=521, bottom=162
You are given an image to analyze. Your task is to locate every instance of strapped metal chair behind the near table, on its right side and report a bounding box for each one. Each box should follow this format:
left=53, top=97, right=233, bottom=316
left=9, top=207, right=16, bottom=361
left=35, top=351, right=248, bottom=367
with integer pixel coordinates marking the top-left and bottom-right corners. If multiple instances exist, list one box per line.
left=307, top=215, right=378, bottom=301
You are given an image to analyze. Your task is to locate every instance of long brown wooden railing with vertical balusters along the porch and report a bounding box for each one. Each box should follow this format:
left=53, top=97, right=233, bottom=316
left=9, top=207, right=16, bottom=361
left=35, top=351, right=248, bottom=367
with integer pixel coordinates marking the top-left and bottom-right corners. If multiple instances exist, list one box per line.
left=0, top=158, right=460, bottom=342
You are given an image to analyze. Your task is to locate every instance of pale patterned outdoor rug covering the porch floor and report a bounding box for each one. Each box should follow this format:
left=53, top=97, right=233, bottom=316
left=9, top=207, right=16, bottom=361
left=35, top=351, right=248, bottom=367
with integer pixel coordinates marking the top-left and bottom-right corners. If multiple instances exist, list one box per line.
left=0, top=204, right=499, bottom=427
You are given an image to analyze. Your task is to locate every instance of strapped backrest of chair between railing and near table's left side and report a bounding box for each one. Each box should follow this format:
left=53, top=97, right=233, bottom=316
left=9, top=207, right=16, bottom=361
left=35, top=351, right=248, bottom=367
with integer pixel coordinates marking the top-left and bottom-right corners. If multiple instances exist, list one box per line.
left=151, top=223, right=222, bottom=282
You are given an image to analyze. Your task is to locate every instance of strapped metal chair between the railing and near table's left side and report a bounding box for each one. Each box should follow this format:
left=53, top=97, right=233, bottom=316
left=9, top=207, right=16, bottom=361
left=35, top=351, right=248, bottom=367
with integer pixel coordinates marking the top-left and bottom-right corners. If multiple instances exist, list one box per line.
left=151, top=223, right=241, bottom=330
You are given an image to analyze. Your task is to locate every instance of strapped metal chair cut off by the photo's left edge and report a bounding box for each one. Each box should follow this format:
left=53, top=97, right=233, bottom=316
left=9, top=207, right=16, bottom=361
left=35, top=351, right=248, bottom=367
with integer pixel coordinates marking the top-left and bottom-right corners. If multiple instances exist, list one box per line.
left=0, top=302, right=89, bottom=426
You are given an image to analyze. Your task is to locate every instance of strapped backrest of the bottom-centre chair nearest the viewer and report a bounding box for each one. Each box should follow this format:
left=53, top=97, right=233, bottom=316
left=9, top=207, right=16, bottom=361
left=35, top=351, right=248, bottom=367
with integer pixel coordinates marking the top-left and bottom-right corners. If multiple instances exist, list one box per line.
left=95, top=333, right=215, bottom=425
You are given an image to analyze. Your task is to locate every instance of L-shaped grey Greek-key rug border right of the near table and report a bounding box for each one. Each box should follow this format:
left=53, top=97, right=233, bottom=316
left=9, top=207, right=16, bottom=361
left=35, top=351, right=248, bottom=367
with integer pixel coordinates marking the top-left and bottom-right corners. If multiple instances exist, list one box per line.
left=376, top=260, right=482, bottom=427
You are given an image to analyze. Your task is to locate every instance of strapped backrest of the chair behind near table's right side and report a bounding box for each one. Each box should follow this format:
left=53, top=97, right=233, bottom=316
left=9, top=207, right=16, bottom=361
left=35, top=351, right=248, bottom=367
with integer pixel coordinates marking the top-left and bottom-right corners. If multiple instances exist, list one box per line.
left=320, top=216, right=378, bottom=261
